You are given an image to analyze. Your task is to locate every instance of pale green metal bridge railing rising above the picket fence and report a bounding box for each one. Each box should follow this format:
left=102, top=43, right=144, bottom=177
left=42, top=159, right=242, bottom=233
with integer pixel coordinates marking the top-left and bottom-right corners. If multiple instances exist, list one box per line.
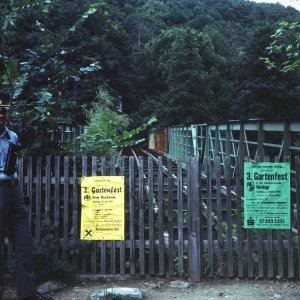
left=149, top=119, right=300, bottom=168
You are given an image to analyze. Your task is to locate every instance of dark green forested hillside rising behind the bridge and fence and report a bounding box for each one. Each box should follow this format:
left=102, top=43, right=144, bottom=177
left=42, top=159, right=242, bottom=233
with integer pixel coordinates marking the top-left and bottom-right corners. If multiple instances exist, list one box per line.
left=0, top=0, right=300, bottom=152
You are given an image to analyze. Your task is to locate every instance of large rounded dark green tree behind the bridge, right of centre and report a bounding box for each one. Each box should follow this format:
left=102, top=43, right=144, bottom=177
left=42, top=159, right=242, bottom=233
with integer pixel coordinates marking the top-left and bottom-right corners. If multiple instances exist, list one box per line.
left=138, top=27, right=230, bottom=125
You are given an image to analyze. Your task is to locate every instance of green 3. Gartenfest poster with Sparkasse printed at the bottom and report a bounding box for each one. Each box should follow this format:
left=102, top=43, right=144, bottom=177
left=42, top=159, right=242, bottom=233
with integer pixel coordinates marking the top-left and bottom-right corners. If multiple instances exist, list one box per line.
left=244, top=162, right=291, bottom=229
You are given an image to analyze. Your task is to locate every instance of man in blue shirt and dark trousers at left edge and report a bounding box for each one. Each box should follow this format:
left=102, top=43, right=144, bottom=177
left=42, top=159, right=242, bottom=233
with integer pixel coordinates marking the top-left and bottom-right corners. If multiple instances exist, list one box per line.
left=0, top=91, right=53, bottom=300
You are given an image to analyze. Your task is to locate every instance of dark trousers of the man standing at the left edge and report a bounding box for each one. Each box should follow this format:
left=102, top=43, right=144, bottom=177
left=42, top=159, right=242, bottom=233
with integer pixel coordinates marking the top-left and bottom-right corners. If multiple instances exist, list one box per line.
left=0, top=182, right=35, bottom=297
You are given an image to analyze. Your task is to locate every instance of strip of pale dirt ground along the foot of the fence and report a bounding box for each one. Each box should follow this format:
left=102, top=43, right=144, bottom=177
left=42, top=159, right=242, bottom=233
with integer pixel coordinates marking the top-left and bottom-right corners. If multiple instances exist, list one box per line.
left=3, top=278, right=300, bottom=300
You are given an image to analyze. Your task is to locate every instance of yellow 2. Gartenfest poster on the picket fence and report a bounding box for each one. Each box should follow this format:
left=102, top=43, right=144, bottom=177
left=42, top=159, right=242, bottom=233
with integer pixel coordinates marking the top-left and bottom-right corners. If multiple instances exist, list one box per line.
left=80, top=176, right=125, bottom=240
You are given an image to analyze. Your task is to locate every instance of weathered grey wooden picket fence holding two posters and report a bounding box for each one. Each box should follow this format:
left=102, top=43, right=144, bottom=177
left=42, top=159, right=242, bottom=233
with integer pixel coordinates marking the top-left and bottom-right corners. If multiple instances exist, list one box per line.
left=7, top=156, right=300, bottom=282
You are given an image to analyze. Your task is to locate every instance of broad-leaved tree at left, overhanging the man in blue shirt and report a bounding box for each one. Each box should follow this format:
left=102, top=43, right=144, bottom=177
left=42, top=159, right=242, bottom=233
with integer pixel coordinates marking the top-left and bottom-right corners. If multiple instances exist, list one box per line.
left=0, top=0, right=101, bottom=153
